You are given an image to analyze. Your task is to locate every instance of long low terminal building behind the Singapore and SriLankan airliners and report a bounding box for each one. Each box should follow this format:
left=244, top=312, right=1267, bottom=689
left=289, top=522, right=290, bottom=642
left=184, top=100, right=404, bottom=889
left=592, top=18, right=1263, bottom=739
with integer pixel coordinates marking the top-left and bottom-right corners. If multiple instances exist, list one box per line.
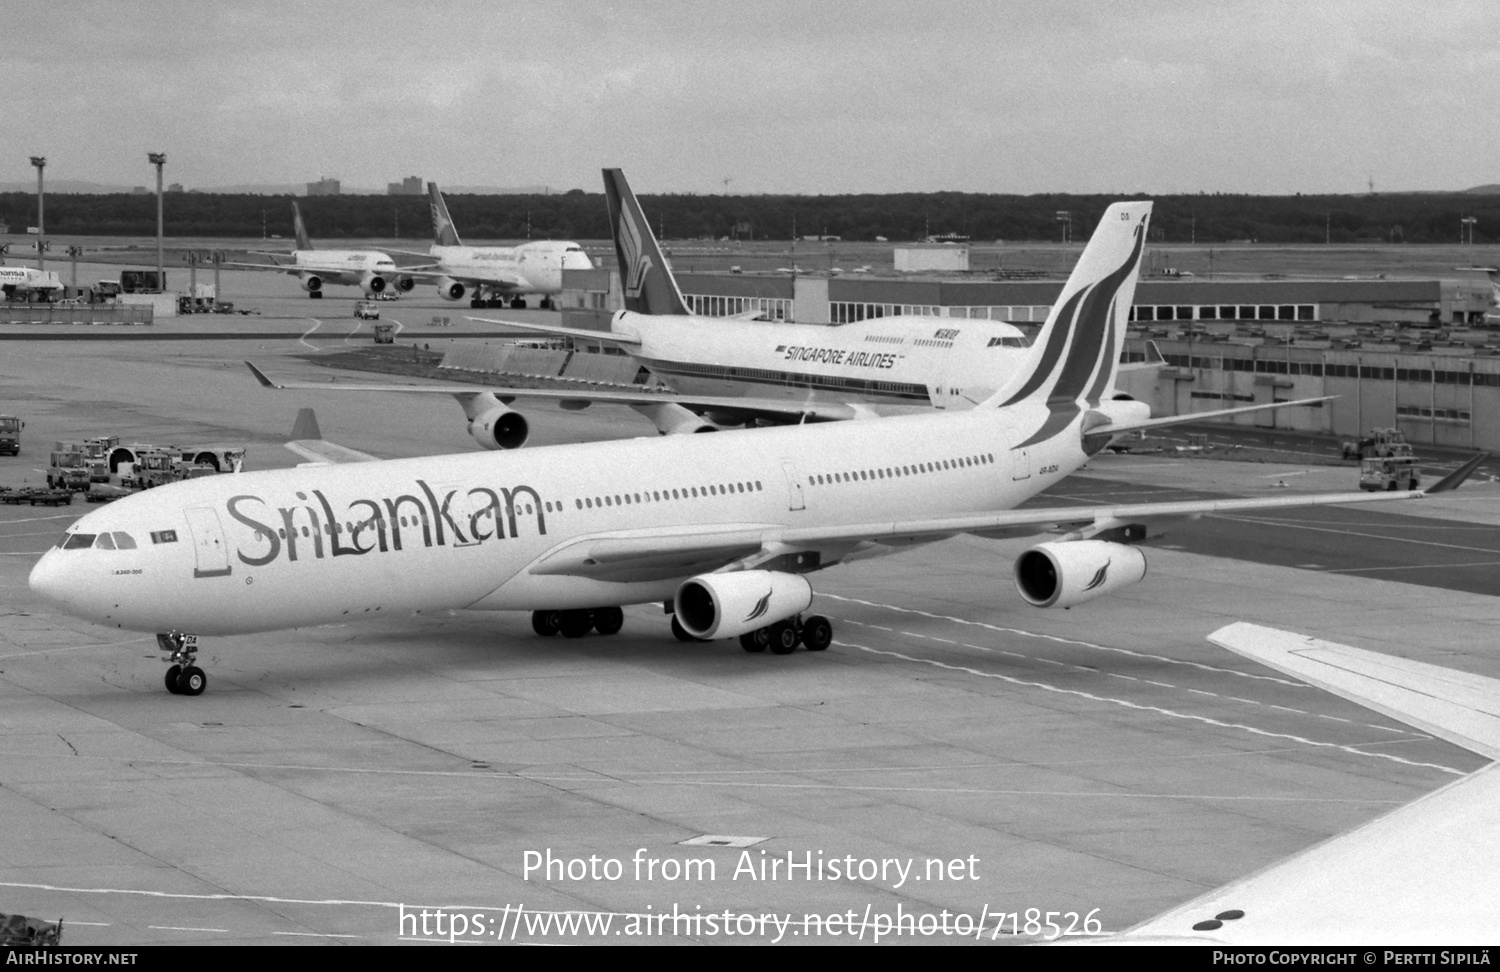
left=560, top=270, right=1500, bottom=449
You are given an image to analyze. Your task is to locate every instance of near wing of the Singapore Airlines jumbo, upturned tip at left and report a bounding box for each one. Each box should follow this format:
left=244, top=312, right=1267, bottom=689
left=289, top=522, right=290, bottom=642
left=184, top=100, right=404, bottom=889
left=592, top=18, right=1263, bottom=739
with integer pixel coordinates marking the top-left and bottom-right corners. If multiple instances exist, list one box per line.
left=245, top=362, right=876, bottom=423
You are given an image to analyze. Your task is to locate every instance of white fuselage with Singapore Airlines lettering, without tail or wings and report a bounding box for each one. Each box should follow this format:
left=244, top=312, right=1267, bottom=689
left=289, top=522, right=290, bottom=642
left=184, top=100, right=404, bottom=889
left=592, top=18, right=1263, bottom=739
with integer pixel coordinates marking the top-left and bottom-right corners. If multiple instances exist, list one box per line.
left=611, top=311, right=1029, bottom=408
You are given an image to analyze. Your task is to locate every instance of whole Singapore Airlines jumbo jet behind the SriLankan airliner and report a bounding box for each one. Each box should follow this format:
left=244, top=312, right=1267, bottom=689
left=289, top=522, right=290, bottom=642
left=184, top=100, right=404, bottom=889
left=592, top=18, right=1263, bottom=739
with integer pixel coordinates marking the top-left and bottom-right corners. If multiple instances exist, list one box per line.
left=252, top=170, right=1266, bottom=449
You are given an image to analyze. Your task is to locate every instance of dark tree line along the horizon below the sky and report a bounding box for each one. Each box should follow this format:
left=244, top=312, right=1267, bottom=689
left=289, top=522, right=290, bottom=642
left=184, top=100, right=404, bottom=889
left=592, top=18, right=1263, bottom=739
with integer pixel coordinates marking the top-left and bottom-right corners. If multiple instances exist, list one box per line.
left=0, top=189, right=1500, bottom=243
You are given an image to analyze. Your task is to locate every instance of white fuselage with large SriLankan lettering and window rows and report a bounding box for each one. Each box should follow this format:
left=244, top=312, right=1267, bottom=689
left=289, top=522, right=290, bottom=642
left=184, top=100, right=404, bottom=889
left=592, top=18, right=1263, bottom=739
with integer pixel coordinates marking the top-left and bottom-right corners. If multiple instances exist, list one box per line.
left=32, top=405, right=1086, bottom=635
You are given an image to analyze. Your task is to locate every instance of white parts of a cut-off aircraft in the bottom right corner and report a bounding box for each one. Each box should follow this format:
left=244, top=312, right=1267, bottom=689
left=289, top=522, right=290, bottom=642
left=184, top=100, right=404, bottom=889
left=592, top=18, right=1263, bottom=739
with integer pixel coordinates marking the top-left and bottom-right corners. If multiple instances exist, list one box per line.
left=1115, top=623, right=1500, bottom=945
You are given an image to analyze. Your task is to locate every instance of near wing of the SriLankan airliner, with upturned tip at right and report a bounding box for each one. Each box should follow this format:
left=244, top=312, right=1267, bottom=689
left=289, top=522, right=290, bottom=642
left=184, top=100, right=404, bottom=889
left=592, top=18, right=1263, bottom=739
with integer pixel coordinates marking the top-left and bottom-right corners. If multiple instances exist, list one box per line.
left=528, top=453, right=1488, bottom=579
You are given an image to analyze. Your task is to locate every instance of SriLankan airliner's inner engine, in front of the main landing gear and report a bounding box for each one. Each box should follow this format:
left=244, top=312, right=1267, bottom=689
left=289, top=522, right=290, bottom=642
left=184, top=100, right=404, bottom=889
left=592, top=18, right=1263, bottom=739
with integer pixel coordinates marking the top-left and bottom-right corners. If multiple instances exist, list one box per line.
left=675, top=570, right=813, bottom=641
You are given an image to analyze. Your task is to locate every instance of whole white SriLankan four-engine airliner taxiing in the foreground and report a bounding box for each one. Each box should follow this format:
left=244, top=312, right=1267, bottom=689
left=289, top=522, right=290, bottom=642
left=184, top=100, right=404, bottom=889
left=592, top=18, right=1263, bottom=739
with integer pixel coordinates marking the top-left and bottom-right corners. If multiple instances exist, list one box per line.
left=30, top=203, right=1481, bottom=695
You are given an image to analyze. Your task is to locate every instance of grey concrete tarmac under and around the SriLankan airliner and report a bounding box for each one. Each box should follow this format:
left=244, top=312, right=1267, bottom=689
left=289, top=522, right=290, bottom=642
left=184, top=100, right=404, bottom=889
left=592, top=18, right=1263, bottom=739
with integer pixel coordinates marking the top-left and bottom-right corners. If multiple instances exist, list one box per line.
left=0, top=275, right=1500, bottom=945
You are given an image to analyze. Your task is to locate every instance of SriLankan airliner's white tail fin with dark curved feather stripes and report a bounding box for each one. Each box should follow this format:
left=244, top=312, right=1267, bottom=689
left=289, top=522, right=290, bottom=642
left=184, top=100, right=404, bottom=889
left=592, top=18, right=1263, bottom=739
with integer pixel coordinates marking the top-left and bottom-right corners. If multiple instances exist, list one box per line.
left=980, top=203, right=1151, bottom=414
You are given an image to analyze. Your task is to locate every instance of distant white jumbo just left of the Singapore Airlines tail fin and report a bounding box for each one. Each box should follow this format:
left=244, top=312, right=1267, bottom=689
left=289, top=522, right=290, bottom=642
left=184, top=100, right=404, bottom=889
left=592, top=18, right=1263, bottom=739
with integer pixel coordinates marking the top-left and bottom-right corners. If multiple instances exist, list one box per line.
left=399, top=183, right=594, bottom=309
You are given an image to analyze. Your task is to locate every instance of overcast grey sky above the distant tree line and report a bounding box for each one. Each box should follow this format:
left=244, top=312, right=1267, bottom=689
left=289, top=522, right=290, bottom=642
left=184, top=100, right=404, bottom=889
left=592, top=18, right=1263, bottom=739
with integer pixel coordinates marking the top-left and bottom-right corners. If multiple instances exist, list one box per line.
left=11, top=0, right=1500, bottom=194
